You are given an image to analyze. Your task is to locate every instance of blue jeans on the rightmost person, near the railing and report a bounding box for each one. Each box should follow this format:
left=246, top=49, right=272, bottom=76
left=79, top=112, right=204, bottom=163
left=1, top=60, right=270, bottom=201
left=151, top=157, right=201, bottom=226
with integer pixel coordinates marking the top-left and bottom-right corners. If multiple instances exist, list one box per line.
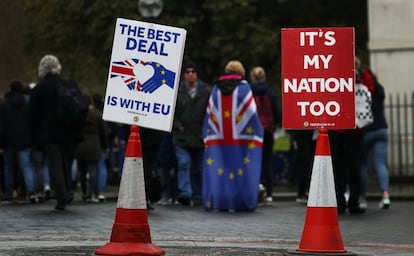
left=361, top=128, right=389, bottom=196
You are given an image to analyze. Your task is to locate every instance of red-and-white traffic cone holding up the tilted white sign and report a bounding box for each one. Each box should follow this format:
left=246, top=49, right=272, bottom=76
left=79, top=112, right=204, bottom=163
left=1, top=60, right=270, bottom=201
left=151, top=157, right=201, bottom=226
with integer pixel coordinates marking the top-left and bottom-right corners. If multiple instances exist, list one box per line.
left=95, top=126, right=164, bottom=256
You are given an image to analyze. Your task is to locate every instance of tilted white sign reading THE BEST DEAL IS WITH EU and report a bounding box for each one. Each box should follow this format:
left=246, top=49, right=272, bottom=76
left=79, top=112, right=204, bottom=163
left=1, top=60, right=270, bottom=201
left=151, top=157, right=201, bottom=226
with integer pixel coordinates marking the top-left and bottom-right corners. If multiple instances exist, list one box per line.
left=103, top=18, right=187, bottom=131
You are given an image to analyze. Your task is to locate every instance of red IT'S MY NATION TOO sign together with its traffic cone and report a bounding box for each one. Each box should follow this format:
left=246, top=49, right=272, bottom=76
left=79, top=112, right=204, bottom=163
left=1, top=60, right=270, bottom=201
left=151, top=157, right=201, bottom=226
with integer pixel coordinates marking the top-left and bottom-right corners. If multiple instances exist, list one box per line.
left=282, top=28, right=355, bottom=255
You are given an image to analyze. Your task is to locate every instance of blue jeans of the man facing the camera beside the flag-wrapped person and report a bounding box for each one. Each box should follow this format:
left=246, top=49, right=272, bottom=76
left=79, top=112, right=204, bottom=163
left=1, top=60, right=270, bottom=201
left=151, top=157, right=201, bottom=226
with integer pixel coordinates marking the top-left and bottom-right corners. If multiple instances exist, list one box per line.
left=175, top=145, right=204, bottom=199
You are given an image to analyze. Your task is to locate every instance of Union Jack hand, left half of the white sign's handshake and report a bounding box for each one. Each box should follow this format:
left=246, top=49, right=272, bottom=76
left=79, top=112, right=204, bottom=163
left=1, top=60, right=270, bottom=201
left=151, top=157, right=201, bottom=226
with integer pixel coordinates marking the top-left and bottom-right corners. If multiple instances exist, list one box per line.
left=111, top=59, right=144, bottom=91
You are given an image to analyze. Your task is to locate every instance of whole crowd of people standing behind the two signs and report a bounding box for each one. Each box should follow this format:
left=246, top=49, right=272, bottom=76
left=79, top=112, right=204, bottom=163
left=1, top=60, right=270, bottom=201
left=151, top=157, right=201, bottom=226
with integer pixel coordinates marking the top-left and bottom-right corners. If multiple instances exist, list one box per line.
left=0, top=55, right=390, bottom=214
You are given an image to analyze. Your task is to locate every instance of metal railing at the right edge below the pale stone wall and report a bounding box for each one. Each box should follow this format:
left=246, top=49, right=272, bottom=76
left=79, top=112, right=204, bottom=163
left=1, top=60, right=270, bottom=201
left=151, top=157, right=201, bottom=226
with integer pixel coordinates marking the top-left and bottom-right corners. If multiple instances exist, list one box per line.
left=385, top=92, right=414, bottom=178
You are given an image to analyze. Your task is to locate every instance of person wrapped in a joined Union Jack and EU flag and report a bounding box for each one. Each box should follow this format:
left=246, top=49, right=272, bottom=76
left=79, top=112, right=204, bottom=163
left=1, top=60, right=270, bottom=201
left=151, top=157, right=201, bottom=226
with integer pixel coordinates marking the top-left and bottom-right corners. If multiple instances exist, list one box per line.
left=203, top=61, right=263, bottom=211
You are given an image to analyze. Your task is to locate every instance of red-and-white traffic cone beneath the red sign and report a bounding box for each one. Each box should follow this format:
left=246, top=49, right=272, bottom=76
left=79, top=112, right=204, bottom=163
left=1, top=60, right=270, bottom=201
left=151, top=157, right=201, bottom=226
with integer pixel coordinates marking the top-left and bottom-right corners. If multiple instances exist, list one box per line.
left=297, top=129, right=346, bottom=253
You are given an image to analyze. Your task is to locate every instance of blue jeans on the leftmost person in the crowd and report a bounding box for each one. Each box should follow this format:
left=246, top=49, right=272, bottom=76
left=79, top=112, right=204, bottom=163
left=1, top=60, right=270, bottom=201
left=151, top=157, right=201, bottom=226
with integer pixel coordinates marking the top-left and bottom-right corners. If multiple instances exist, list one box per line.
left=4, top=148, right=35, bottom=199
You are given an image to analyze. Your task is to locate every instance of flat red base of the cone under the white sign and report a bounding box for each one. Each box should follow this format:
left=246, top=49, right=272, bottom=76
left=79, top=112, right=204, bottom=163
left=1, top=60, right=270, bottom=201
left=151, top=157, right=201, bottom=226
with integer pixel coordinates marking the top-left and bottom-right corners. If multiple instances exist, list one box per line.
left=95, top=242, right=165, bottom=256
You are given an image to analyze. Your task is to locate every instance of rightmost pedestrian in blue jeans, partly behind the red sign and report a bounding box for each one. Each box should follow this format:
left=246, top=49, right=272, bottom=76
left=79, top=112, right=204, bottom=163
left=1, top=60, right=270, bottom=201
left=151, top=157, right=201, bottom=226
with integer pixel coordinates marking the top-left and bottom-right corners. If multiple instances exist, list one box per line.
left=358, top=65, right=391, bottom=209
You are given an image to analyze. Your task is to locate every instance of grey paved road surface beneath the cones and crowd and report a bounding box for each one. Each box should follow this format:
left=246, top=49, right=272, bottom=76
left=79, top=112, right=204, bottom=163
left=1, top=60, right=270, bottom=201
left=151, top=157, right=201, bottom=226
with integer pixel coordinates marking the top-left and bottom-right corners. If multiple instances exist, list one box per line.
left=0, top=190, right=414, bottom=256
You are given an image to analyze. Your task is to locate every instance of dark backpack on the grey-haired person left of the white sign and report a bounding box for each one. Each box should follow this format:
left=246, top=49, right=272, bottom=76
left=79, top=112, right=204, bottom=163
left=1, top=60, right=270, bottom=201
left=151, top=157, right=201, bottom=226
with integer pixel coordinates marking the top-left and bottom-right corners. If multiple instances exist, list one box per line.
left=56, top=78, right=89, bottom=131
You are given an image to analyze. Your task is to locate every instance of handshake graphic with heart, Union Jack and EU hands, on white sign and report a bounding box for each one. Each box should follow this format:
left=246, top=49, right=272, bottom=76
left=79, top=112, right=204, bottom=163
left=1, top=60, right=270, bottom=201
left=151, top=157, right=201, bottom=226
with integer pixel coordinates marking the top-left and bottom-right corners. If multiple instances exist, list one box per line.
left=111, top=59, right=175, bottom=93
